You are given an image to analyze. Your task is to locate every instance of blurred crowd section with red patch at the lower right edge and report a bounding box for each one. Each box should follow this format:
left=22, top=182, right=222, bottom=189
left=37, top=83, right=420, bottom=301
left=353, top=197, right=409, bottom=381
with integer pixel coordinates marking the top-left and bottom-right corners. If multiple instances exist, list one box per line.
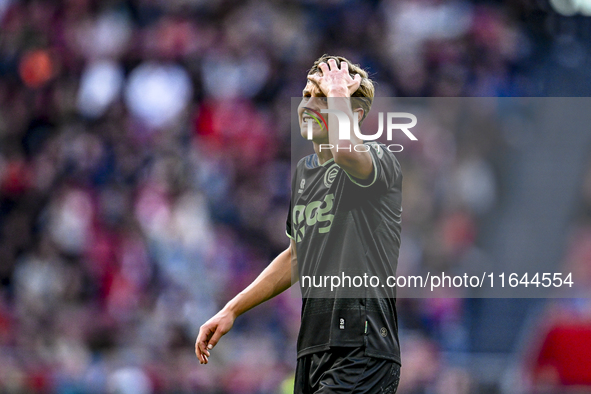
left=521, top=163, right=591, bottom=394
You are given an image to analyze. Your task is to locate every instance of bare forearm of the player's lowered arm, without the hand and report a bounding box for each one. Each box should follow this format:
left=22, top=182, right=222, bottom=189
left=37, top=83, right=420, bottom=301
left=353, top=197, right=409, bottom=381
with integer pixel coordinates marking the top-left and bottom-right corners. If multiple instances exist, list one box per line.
left=224, top=248, right=292, bottom=317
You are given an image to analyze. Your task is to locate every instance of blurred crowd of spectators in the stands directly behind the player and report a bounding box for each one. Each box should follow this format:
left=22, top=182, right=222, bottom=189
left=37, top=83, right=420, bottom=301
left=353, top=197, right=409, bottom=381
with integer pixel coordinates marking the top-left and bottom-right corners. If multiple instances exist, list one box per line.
left=0, top=0, right=588, bottom=394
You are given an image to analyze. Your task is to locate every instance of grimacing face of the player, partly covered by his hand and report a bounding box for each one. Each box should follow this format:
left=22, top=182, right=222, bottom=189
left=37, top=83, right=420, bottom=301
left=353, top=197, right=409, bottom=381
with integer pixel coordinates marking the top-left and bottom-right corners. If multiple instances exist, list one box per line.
left=298, top=74, right=328, bottom=144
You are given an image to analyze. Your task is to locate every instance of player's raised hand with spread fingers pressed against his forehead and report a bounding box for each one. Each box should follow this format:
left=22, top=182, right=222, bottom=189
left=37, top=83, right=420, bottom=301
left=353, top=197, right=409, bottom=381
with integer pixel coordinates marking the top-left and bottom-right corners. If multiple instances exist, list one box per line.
left=308, top=59, right=361, bottom=97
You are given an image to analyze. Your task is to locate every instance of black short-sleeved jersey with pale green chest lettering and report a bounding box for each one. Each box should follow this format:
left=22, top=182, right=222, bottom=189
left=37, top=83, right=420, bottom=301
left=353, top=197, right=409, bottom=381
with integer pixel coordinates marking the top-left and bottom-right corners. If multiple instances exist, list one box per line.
left=286, top=142, right=402, bottom=363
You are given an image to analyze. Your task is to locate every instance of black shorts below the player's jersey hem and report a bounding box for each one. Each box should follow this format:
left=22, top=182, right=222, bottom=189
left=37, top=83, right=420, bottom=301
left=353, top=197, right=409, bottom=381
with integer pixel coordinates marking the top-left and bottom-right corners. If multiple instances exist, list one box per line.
left=294, top=347, right=400, bottom=394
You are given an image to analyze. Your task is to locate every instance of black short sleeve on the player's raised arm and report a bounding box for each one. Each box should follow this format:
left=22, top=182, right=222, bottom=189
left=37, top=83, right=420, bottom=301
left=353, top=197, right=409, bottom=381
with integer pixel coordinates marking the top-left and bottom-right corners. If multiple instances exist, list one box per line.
left=345, top=142, right=402, bottom=189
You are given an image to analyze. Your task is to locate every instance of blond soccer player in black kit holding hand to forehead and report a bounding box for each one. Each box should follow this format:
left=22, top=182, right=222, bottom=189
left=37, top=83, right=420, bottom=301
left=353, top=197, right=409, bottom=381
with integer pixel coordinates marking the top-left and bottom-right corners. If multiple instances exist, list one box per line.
left=195, top=55, right=402, bottom=394
